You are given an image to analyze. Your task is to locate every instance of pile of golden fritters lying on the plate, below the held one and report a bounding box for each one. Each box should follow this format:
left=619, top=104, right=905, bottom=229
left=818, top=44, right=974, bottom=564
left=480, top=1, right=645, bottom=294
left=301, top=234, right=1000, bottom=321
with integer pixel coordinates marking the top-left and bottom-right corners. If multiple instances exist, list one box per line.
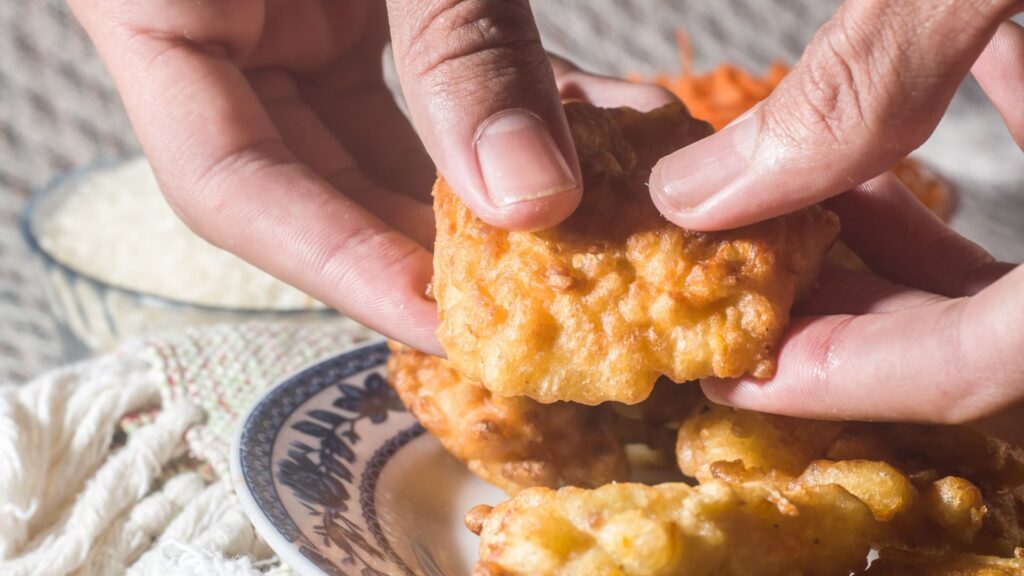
left=388, top=346, right=1024, bottom=576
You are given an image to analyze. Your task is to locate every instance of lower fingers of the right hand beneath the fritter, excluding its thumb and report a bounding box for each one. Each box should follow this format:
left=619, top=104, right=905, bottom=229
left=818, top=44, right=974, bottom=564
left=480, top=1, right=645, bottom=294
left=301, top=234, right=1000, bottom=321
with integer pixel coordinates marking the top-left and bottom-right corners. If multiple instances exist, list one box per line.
left=701, top=170, right=1024, bottom=443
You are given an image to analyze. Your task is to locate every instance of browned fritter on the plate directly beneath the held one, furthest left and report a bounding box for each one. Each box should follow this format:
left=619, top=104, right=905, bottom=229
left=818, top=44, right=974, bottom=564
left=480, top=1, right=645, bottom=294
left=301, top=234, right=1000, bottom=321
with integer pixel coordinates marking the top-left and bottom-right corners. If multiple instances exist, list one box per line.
left=387, top=341, right=703, bottom=494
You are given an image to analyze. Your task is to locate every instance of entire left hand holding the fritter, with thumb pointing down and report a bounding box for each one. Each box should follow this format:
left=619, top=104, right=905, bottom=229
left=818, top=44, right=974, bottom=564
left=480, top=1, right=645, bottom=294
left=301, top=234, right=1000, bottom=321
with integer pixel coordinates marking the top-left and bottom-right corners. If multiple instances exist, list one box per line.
left=70, top=0, right=671, bottom=354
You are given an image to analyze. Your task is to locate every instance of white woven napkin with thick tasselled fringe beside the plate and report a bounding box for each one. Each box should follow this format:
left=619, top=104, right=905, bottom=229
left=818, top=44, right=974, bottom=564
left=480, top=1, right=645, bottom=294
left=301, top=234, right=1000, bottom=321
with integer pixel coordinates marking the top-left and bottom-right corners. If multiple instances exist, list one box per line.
left=0, top=322, right=374, bottom=576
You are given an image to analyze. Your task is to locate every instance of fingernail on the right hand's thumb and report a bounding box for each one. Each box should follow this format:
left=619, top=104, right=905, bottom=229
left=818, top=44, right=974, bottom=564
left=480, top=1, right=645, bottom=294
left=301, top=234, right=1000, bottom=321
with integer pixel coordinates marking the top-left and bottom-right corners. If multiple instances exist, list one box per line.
left=650, top=112, right=761, bottom=212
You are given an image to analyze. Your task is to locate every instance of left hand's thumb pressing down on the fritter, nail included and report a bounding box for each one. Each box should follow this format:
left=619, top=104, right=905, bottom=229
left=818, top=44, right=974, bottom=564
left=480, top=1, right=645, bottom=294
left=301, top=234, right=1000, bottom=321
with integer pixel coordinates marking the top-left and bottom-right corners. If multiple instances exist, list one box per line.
left=388, top=0, right=582, bottom=230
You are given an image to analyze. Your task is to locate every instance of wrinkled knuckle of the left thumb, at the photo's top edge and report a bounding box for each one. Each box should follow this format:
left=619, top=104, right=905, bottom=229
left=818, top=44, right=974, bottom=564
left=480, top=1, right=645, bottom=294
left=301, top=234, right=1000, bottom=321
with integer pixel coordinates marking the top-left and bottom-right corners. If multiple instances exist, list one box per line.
left=404, top=0, right=547, bottom=87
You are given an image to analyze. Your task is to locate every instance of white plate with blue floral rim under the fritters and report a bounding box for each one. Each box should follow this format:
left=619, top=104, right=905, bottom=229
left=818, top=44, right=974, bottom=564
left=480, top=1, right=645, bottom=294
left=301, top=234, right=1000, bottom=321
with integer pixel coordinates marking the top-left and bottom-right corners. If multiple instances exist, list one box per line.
left=231, top=342, right=504, bottom=576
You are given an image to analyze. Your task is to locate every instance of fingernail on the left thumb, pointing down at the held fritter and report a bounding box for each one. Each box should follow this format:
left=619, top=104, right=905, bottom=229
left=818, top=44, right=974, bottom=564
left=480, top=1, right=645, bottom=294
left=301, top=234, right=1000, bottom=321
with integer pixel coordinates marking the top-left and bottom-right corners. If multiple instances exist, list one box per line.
left=474, top=110, right=577, bottom=207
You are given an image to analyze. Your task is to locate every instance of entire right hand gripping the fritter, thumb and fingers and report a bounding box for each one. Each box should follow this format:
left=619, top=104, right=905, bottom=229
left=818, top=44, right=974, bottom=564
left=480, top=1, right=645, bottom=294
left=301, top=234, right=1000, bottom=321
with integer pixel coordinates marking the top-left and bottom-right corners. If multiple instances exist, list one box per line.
left=638, top=0, right=1024, bottom=436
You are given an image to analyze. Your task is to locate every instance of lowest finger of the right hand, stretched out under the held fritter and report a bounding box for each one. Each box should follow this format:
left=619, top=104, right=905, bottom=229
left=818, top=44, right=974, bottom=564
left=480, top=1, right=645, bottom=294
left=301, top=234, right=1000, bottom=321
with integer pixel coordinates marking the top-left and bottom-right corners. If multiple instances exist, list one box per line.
left=701, top=266, right=1024, bottom=423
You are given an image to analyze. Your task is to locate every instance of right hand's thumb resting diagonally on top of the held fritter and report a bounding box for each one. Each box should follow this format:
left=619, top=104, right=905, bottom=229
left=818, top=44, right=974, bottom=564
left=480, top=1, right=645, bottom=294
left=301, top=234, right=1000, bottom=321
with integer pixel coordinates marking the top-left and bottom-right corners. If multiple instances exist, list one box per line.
left=651, top=0, right=1020, bottom=231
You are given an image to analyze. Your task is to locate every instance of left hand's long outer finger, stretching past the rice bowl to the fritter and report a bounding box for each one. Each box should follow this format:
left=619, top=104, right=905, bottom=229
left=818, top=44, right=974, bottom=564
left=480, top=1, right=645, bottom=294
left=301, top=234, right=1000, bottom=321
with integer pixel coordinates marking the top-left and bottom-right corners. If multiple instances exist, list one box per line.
left=67, top=0, right=440, bottom=354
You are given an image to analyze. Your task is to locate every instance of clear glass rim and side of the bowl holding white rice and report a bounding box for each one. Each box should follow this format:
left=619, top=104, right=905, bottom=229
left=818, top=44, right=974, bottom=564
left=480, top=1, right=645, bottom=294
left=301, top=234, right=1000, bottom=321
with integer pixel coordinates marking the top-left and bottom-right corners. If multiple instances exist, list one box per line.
left=20, top=157, right=346, bottom=360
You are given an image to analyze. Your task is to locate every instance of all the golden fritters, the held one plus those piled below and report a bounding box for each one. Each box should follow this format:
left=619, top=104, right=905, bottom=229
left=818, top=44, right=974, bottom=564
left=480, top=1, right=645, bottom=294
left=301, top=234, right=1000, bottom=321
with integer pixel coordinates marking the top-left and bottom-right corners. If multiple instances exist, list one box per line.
left=388, top=102, right=1024, bottom=576
